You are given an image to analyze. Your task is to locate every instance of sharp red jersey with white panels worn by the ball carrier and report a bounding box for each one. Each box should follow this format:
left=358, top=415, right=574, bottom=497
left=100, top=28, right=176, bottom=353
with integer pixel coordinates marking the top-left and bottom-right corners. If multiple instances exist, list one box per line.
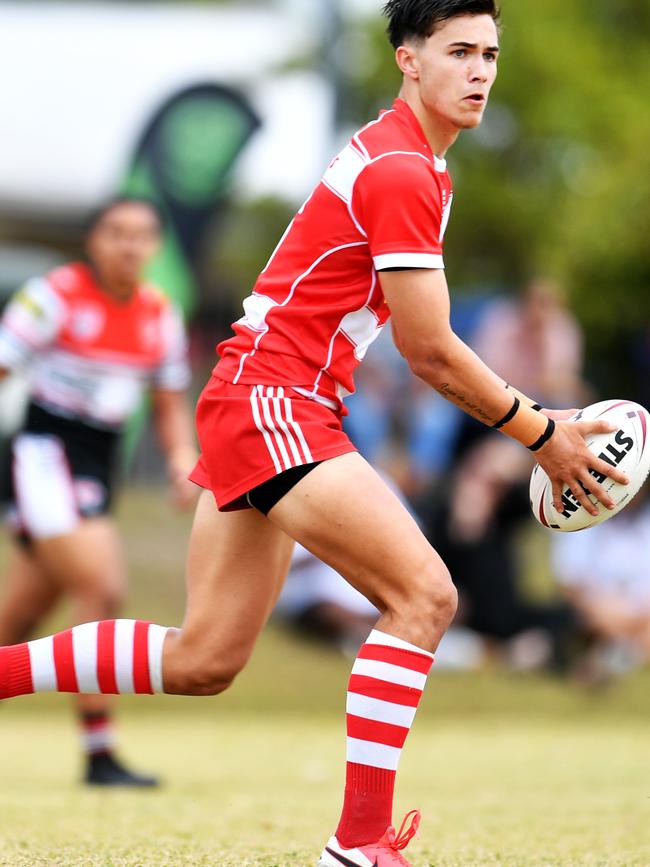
left=214, top=99, right=453, bottom=405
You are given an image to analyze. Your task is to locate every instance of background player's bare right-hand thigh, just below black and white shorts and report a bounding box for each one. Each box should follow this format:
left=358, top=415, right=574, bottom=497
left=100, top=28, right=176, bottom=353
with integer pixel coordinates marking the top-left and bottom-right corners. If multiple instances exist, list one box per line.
left=32, top=515, right=126, bottom=604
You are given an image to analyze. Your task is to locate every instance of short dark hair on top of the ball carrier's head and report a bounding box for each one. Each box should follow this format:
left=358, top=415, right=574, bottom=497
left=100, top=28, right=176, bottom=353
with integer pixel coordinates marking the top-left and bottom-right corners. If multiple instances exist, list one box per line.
left=384, top=0, right=500, bottom=48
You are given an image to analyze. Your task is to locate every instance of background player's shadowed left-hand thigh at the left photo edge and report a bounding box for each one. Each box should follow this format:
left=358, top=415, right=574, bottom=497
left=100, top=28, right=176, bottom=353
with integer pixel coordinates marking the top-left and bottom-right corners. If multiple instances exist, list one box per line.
left=0, top=544, right=60, bottom=645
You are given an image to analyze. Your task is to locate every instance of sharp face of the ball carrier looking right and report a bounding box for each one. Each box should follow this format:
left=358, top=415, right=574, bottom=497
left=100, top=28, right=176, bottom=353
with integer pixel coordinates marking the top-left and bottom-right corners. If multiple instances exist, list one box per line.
left=413, top=15, right=499, bottom=130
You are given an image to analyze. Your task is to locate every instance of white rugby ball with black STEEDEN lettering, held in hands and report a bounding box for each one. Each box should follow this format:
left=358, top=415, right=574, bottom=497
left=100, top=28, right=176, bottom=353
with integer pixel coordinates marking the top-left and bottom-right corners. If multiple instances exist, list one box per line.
left=530, top=400, right=650, bottom=533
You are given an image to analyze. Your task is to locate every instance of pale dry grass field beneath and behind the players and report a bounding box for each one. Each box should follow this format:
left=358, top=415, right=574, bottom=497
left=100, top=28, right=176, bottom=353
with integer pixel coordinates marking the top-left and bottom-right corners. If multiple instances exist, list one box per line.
left=0, top=497, right=650, bottom=867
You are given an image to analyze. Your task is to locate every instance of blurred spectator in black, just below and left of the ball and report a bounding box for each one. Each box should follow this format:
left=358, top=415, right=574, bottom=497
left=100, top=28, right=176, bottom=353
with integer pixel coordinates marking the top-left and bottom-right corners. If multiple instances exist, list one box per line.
left=429, top=434, right=575, bottom=671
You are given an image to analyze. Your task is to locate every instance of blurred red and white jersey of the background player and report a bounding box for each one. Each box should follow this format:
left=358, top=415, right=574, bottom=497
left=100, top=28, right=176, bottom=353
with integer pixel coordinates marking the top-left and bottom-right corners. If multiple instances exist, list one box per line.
left=0, top=262, right=190, bottom=428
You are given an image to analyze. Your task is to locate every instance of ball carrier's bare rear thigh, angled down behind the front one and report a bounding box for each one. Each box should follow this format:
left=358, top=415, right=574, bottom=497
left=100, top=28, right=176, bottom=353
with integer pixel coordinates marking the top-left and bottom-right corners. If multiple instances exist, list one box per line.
left=175, top=491, right=293, bottom=655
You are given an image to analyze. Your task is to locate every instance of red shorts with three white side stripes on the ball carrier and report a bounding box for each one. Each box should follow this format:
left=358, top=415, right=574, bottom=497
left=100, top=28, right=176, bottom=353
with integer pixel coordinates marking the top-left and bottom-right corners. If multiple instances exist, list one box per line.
left=190, top=376, right=356, bottom=512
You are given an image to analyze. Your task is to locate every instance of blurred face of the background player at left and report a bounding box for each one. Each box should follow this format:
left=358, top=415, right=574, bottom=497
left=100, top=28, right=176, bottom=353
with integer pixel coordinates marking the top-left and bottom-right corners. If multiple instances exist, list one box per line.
left=86, top=202, right=160, bottom=286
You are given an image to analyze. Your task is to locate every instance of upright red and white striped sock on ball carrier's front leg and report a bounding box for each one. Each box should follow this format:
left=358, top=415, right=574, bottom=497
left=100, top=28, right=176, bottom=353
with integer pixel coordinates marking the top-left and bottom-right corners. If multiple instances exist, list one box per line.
left=336, top=629, right=433, bottom=849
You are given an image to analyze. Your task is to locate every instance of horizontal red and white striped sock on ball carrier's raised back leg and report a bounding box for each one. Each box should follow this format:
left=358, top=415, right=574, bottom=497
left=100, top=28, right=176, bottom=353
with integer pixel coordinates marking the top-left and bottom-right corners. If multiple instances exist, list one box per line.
left=0, top=620, right=168, bottom=699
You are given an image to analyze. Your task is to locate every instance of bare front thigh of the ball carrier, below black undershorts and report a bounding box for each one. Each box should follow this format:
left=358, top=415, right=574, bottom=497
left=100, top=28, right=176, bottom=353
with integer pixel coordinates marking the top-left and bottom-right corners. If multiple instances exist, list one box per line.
left=269, top=452, right=453, bottom=611
